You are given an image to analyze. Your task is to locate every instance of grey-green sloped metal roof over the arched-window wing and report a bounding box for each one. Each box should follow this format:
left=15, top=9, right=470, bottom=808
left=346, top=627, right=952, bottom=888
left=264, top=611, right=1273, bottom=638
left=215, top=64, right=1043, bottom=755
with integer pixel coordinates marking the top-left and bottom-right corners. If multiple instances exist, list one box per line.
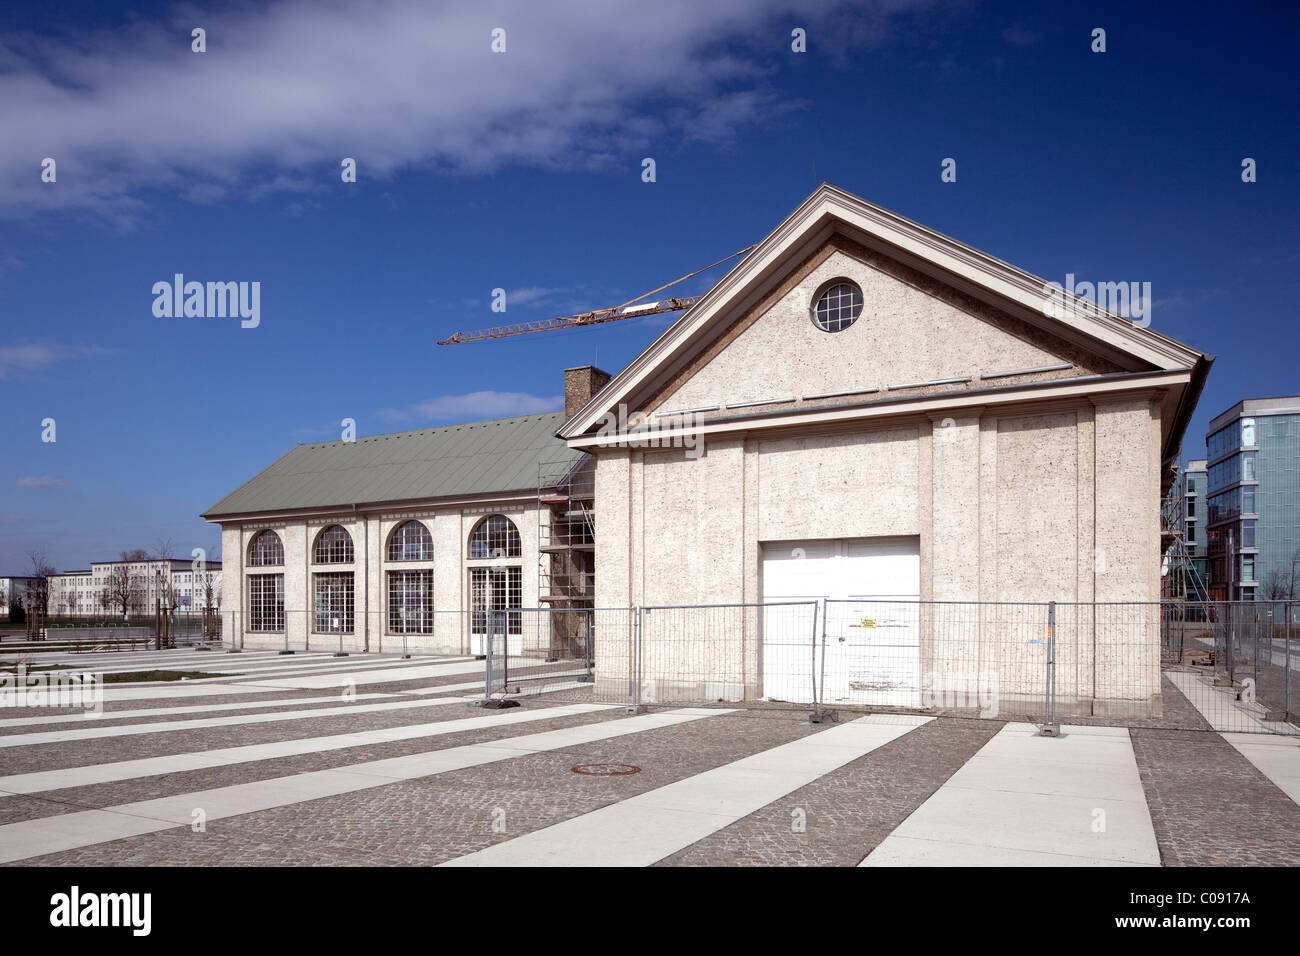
left=203, top=411, right=582, bottom=518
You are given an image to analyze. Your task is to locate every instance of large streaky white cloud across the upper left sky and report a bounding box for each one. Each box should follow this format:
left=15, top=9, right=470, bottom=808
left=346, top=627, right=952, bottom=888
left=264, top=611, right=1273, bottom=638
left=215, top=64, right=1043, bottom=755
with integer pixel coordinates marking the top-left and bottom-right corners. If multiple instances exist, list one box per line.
left=0, top=0, right=932, bottom=220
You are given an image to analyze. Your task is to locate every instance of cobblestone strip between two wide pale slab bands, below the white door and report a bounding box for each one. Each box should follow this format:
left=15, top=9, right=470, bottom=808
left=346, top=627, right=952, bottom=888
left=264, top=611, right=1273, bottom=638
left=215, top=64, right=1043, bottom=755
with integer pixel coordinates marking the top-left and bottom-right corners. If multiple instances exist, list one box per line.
left=658, top=718, right=1004, bottom=866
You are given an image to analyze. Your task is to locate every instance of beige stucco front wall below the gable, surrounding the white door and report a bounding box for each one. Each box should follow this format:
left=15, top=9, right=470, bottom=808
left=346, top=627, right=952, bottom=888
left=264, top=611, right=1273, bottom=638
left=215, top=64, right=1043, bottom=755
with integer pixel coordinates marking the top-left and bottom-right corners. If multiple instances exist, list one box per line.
left=597, top=397, right=1160, bottom=701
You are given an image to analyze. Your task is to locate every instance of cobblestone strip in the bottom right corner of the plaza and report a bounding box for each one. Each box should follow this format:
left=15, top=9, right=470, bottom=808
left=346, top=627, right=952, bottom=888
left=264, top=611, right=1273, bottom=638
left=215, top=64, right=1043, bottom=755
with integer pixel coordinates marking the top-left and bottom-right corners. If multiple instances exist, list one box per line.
left=1130, top=728, right=1300, bottom=866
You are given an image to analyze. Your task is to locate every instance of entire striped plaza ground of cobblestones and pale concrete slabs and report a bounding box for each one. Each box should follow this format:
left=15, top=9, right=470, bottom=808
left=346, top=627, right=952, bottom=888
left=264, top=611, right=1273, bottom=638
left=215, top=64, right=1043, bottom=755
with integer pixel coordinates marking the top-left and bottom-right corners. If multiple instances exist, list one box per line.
left=0, top=649, right=1300, bottom=866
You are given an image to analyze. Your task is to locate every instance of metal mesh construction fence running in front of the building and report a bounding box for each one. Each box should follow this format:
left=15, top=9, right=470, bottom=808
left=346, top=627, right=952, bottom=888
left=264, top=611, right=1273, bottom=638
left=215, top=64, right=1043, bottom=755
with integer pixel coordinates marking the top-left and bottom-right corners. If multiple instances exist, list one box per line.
left=205, top=598, right=1300, bottom=734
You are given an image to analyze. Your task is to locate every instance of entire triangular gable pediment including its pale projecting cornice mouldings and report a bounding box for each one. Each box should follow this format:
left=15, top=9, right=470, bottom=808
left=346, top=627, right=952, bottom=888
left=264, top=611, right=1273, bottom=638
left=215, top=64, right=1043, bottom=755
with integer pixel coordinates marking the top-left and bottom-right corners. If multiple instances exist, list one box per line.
left=560, top=185, right=1208, bottom=447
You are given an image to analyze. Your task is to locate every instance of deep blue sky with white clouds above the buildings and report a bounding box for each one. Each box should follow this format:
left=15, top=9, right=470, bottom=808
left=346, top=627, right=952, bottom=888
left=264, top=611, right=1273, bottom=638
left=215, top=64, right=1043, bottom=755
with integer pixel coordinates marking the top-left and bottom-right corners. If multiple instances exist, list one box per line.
left=0, top=0, right=1300, bottom=574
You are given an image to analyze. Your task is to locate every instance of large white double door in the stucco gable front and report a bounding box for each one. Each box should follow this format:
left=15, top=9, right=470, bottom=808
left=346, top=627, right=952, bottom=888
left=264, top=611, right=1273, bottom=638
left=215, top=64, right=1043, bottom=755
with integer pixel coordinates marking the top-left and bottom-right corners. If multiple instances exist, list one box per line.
left=763, top=537, right=920, bottom=706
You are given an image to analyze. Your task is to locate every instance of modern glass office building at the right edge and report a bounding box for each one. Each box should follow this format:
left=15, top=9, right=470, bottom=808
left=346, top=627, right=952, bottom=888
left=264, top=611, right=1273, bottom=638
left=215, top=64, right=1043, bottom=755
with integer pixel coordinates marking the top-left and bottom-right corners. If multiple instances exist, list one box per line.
left=1205, top=395, right=1300, bottom=601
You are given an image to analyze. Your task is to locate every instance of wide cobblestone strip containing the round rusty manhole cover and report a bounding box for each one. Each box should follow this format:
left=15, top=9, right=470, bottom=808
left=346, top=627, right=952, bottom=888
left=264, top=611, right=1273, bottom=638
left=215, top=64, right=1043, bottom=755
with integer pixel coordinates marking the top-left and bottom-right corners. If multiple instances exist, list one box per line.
left=22, top=711, right=823, bottom=866
